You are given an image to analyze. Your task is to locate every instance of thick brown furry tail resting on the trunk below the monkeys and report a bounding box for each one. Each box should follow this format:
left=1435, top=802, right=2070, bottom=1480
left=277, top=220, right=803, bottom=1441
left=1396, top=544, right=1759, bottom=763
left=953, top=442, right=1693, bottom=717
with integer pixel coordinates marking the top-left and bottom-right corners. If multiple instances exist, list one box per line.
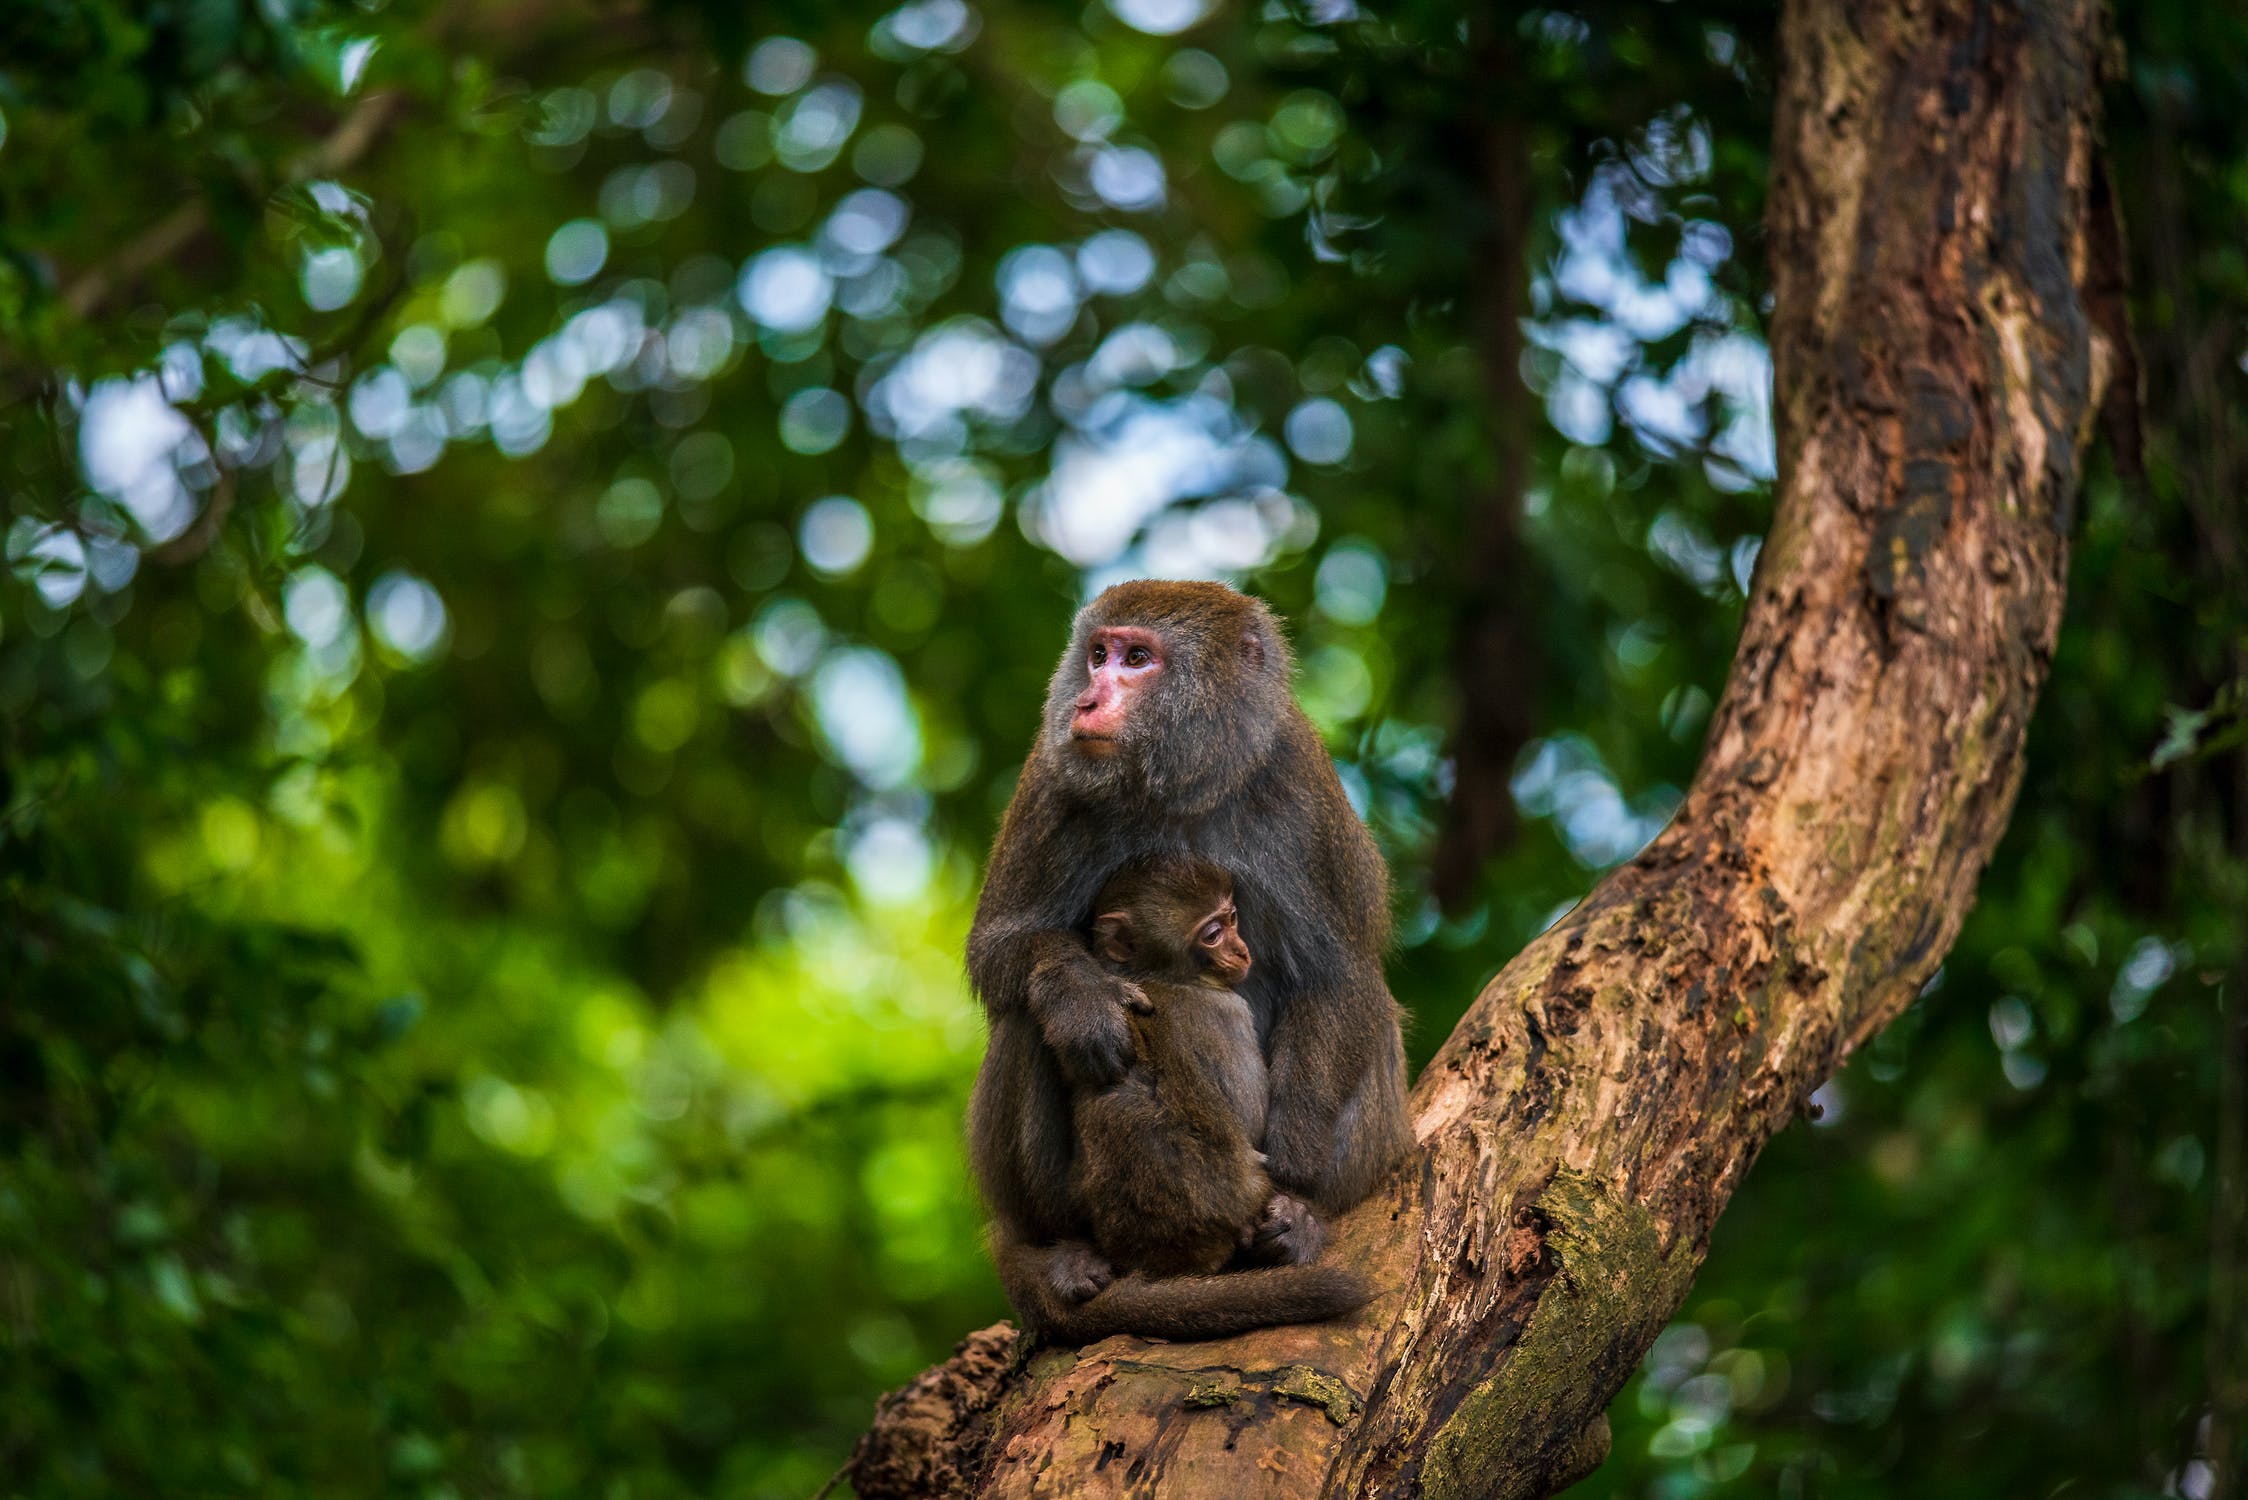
left=1041, top=1266, right=1374, bottom=1345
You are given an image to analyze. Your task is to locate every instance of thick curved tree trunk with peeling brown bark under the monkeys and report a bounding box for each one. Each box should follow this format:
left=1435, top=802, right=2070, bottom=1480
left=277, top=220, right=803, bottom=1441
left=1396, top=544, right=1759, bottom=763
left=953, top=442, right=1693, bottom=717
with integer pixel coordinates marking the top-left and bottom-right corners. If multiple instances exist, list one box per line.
left=852, top=0, right=2115, bottom=1500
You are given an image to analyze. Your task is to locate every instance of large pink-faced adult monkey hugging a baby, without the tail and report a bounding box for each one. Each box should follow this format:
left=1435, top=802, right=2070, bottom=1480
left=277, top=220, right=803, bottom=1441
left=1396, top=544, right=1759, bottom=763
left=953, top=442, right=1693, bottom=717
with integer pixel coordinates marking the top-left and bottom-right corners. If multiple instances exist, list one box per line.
left=967, top=582, right=1409, bottom=1316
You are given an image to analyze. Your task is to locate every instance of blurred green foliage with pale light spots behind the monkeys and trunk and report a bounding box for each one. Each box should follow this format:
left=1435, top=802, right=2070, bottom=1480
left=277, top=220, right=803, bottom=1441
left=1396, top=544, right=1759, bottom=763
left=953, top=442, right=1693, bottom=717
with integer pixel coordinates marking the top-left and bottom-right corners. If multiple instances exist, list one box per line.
left=0, top=0, right=2248, bottom=1498
